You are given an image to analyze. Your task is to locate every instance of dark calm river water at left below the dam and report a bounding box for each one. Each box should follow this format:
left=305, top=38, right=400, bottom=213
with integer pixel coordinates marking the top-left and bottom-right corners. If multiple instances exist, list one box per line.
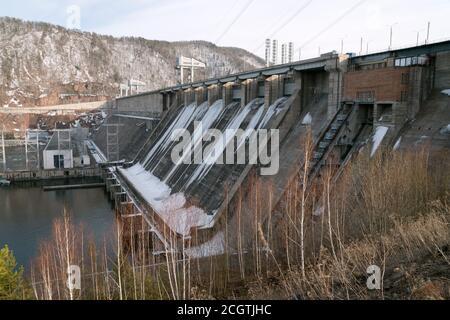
left=0, top=181, right=114, bottom=268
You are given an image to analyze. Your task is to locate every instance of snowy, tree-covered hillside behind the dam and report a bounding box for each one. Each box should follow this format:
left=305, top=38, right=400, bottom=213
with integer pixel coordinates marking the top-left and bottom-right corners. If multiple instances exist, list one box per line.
left=0, top=17, right=264, bottom=107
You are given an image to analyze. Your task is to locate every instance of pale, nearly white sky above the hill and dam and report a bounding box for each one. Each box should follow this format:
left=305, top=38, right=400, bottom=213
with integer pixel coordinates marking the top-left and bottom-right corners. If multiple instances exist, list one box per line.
left=0, top=0, right=450, bottom=58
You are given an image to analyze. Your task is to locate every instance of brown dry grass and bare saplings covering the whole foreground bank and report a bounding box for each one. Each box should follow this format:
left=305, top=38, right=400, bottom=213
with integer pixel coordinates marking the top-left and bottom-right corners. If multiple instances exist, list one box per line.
left=32, top=146, right=450, bottom=300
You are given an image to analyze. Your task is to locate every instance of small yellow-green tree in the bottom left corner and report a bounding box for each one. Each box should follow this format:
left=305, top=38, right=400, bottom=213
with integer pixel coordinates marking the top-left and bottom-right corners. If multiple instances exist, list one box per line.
left=0, top=246, right=26, bottom=300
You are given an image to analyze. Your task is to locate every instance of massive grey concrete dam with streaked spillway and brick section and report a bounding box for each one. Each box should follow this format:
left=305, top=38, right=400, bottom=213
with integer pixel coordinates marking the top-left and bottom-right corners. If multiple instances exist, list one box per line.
left=93, top=42, right=450, bottom=256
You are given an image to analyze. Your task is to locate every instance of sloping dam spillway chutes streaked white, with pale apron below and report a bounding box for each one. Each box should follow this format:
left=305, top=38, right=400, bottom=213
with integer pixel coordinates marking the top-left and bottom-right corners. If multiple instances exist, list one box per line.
left=119, top=98, right=286, bottom=236
